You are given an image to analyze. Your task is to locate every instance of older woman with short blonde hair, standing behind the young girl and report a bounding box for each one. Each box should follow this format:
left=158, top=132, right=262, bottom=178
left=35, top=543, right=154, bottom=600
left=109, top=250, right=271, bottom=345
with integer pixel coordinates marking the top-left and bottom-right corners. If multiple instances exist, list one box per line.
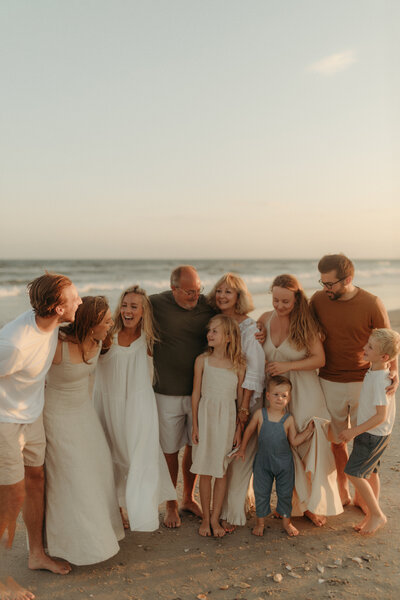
left=208, top=273, right=265, bottom=532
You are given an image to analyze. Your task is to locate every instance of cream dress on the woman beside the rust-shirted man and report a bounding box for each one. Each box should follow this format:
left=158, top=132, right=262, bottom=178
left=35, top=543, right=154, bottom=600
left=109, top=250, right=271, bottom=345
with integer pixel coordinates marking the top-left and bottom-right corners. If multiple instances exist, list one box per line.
left=264, top=315, right=343, bottom=517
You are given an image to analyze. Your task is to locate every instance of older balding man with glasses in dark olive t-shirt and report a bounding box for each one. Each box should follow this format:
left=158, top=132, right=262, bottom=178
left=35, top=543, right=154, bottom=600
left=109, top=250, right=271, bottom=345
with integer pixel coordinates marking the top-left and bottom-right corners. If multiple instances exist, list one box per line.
left=150, top=265, right=215, bottom=527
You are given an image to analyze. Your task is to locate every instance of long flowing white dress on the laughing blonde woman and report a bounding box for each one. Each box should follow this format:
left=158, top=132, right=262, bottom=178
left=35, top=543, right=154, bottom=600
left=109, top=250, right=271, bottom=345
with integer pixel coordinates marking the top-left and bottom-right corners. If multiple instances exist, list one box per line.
left=94, top=332, right=177, bottom=531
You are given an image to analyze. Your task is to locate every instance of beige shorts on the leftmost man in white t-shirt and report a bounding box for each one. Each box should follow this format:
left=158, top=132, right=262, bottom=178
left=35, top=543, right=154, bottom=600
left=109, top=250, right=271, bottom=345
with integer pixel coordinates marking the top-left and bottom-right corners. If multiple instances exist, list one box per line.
left=0, top=415, right=46, bottom=485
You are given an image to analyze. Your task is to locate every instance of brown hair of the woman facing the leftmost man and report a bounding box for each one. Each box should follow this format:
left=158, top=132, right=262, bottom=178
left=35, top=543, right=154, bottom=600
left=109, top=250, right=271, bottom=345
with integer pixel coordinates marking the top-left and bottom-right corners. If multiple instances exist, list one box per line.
left=60, top=296, right=110, bottom=363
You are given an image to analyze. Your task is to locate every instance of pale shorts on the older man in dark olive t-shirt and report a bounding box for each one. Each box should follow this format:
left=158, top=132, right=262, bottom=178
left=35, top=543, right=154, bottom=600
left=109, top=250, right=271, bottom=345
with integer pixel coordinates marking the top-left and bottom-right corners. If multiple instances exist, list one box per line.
left=156, top=394, right=192, bottom=454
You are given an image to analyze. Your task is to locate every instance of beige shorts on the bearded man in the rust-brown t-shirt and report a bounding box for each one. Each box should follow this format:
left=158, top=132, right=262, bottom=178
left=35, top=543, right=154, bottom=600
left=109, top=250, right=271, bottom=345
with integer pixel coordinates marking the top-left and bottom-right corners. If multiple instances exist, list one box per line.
left=319, top=377, right=362, bottom=444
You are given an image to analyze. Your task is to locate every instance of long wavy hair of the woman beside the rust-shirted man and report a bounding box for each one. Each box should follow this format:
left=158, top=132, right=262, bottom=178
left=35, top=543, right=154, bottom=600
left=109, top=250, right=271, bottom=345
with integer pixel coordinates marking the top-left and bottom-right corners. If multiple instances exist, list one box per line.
left=270, top=273, right=321, bottom=352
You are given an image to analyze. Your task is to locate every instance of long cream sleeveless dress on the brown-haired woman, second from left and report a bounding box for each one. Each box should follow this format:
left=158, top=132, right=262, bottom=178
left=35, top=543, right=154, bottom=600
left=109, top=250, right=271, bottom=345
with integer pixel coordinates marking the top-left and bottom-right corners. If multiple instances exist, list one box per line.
left=43, top=342, right=124, bottom=565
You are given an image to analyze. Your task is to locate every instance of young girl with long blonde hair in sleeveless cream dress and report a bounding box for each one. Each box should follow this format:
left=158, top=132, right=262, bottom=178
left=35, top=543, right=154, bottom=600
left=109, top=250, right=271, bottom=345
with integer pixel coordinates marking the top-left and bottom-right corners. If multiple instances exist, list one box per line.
left=191, top=315, right=245, bottom=537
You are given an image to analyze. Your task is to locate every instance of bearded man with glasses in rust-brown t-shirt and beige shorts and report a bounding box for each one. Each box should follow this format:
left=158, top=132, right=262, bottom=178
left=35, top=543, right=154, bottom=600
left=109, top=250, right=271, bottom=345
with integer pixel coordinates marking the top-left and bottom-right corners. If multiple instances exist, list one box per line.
left=311, top=254, right=398, bottom=506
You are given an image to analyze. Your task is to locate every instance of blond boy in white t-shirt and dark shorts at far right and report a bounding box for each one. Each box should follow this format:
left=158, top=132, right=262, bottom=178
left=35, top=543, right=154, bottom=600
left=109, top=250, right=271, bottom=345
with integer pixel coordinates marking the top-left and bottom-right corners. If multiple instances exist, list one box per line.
left=339, top=329, right=400, bottom=535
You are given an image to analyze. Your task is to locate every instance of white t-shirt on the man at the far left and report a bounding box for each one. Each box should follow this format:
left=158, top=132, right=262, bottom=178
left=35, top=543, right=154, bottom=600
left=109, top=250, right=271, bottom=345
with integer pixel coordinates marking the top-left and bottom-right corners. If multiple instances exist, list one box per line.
left=0, top=310, right=58, bottom=423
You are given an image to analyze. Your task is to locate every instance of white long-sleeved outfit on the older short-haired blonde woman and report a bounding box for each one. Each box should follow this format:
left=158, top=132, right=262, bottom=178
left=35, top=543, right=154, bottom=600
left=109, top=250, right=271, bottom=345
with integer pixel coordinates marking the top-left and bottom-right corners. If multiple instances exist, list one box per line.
left=221, top=317, right=265, bottom=525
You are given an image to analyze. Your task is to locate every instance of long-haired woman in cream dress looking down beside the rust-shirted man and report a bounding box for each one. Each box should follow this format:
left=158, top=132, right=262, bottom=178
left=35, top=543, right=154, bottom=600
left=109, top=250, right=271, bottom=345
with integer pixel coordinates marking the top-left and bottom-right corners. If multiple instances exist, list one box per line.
left=260, top=274, right=343, bottom=527
